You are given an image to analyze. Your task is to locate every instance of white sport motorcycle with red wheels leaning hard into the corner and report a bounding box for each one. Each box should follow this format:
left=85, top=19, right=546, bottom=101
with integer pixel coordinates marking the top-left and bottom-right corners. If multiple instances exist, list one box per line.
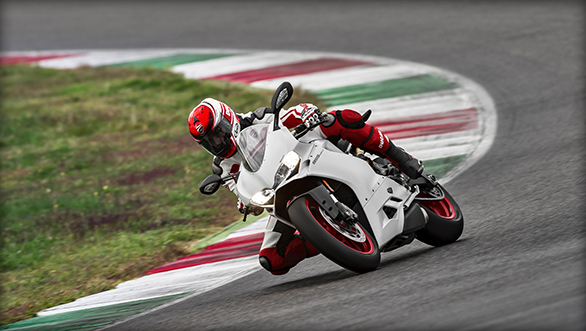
left=200, top=82, right=464, bottom=273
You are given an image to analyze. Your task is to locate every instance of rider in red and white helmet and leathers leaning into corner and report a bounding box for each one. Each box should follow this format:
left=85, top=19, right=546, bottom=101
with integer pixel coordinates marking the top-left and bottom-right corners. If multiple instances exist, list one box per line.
left=188, top=98, right=423, bottom=275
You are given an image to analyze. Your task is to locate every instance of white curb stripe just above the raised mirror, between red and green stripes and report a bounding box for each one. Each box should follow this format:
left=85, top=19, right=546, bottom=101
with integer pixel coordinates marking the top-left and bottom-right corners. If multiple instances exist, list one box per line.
left=251, top=63, right=425, bottom=91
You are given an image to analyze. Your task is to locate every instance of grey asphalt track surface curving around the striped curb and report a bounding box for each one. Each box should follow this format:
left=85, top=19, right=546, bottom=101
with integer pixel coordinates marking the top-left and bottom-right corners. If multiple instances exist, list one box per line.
left=1, top=1, right=586, bottom=330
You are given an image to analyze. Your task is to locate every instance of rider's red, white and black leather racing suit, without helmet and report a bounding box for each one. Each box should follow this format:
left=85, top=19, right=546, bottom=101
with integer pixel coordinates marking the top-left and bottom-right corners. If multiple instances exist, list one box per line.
left=213, top=104, right=423, bottom=275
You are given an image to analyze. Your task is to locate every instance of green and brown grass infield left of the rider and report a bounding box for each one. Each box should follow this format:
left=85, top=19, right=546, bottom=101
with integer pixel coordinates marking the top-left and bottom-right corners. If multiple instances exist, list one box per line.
left=0, top=65, right=319, bottom=324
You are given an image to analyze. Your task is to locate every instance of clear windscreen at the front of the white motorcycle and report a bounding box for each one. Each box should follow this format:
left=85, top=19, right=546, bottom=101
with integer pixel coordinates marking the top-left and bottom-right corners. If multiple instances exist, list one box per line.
left=238, top=124, right=269, bottom=172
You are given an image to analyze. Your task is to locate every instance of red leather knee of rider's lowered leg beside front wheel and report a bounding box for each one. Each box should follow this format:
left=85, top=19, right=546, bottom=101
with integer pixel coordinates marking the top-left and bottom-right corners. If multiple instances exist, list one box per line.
left=258, top=236, right=319, bottom=275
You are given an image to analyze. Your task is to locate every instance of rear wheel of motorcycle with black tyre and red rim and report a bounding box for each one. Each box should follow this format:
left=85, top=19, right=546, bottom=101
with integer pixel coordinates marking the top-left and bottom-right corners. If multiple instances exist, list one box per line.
left=416, top=185, right=464, bottom=246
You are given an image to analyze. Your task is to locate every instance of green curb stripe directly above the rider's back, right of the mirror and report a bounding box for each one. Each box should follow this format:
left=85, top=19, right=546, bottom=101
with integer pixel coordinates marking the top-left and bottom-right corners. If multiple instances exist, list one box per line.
left=313, top=74, right=459, bottom=106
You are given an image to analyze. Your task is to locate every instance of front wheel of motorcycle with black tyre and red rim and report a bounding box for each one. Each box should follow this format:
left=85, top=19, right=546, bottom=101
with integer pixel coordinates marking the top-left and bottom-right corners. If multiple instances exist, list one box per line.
left=288, top=196, right=380, bottom=273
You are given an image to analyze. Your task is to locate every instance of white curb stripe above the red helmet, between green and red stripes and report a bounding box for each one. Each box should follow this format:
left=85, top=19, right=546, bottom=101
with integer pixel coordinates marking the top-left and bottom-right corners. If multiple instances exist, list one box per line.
left=171, top=52, right=320, bottom=79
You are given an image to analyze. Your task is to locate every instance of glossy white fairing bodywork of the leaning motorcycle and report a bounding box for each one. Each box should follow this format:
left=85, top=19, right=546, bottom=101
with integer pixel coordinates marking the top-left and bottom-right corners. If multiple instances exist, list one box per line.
left=237, top=125, right=412, bottom=248
